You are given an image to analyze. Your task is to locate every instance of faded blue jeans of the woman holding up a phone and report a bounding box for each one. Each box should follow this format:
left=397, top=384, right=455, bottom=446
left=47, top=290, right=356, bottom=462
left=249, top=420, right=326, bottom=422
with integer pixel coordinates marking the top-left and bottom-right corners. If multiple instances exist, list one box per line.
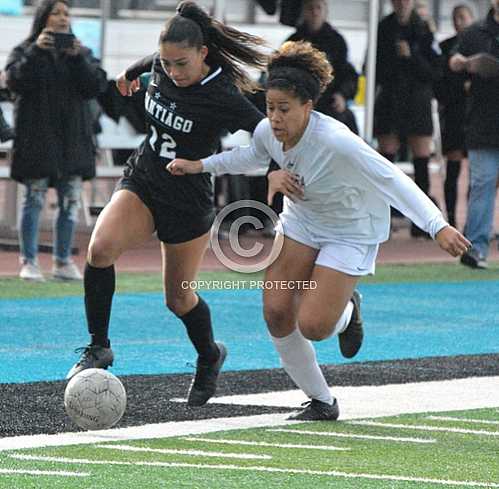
left=19, top=176, right=82, bottom=265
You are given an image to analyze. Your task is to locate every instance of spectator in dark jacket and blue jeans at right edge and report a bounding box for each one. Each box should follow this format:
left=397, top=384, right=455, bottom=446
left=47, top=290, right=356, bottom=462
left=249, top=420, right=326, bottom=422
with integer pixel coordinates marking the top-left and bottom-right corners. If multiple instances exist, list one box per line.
left=449, top=0, right=499, bottom=268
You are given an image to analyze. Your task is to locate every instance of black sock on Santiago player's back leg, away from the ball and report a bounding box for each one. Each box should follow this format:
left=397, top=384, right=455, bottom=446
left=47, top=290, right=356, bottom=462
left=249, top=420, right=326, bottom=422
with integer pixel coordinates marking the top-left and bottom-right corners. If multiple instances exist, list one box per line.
left=179, top=296, right=220, bottom=363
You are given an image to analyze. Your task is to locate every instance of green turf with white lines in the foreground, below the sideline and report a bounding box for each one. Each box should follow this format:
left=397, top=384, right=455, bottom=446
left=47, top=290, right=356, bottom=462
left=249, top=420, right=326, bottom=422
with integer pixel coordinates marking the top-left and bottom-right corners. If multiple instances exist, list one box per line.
left=0, top=409, right=499, bottom=489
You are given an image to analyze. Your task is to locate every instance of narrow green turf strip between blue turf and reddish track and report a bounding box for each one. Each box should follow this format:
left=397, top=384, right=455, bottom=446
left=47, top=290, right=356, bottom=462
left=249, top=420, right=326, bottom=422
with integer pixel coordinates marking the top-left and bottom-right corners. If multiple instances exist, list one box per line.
left=0, top=262, right=499, bottom=299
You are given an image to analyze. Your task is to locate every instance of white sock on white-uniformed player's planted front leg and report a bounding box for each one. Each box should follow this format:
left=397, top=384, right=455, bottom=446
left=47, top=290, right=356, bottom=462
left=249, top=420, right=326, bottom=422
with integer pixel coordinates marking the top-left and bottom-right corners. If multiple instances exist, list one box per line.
left=271, top=328, right=334, bottom=404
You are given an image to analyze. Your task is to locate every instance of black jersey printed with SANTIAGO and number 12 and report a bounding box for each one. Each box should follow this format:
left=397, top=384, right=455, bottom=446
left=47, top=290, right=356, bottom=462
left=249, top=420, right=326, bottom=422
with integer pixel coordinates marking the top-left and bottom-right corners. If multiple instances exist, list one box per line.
left=127, top=55, right=264, bottom=213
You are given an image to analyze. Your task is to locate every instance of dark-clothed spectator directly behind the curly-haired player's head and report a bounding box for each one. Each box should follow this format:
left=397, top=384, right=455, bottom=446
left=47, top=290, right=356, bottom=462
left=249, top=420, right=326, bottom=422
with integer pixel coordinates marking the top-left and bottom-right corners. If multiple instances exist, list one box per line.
left=287, top=0, right=359, bottom=134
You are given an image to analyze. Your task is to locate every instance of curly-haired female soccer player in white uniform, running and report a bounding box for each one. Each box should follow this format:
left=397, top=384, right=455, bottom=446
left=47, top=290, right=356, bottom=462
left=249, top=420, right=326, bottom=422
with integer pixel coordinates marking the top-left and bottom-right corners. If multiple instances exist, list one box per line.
left=168, top=42, right=470, bottom=420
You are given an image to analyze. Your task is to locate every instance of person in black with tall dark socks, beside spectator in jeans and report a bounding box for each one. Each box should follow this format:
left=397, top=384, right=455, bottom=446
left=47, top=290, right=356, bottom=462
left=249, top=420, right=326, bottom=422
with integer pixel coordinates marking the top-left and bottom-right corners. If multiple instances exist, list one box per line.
left=435, top=4, right=473, bottom=227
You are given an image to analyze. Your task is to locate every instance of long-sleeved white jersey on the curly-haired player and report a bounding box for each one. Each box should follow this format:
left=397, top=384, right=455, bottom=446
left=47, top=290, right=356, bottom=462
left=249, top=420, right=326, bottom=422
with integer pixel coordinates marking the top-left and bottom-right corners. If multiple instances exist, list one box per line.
left=202, top=111, right=448, bottom=244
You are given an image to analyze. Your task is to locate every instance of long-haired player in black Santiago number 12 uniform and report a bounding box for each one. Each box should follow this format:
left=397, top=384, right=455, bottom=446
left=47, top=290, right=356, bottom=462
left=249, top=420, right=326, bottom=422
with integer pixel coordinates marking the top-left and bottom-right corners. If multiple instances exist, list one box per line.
left=67, top=2, right=266, bottom=406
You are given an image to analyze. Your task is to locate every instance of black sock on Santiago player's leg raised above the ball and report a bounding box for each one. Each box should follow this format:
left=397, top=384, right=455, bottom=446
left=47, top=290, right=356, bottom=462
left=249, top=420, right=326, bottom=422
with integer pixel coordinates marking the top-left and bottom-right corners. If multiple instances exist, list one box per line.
left=83, top=263, right=116, bottom=348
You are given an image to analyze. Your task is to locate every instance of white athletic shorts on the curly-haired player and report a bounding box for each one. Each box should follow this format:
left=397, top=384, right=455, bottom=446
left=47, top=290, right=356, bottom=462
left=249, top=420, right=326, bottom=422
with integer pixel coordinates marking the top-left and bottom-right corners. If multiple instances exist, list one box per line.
left=277, top=213, right=379, bottom=276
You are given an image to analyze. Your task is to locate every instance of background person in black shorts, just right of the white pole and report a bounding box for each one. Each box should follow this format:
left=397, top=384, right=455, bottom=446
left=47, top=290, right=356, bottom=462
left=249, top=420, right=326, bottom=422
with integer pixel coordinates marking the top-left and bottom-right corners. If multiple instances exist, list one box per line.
left=374, top=0, right=441, bottom=237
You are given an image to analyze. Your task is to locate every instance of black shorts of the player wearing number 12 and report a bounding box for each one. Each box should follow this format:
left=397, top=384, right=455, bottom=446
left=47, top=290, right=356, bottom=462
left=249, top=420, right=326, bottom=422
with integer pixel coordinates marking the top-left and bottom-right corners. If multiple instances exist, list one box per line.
left=115, top=168, right=215, bottom=244
